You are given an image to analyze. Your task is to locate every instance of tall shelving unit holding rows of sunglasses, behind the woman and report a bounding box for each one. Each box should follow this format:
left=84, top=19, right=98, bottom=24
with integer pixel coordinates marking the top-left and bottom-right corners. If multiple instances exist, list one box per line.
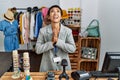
left=62, top=6, right=81, bottom=70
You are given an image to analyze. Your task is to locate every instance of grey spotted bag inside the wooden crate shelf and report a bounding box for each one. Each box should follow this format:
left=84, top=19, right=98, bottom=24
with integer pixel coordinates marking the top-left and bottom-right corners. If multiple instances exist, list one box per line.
left=82, top=47, right=97, bottom=59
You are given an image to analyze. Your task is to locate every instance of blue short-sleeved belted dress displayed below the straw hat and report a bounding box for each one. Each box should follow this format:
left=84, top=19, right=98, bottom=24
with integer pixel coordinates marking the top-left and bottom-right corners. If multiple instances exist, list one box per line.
left=0, top=20, right=19, bottom=52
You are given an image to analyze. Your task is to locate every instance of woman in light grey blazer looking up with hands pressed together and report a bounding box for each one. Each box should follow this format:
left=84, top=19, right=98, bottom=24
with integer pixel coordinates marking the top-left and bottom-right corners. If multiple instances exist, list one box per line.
left=35, top=5, right=76, bottom=72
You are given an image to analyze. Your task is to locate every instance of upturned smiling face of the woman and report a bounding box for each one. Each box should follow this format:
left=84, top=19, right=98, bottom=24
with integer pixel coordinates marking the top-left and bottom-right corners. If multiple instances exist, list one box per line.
left=49, top=7, right=62, bottom=23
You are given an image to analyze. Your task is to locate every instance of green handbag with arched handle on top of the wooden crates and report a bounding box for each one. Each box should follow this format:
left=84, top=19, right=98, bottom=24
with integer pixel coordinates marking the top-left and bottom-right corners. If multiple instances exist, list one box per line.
left=86, top=19, right=100, bottom=37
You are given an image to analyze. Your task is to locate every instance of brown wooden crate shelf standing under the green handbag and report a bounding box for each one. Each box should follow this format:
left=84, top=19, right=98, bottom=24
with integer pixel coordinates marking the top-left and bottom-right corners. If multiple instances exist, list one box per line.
left=78, top=37, right=101, bottom=71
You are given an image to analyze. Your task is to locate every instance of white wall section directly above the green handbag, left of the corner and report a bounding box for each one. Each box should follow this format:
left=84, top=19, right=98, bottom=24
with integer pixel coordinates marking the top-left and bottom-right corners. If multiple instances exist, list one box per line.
left=81, top=0, right=98, bottom=29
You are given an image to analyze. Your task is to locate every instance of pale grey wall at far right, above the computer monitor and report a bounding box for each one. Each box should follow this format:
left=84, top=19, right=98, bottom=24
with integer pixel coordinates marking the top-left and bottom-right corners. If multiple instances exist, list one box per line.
left=98, top=0, right=120, bottom=68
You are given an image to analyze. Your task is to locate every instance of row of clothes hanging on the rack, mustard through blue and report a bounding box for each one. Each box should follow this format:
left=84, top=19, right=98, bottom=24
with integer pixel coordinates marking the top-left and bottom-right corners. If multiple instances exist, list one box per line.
left=14, top=9, right=43, bottom=44
